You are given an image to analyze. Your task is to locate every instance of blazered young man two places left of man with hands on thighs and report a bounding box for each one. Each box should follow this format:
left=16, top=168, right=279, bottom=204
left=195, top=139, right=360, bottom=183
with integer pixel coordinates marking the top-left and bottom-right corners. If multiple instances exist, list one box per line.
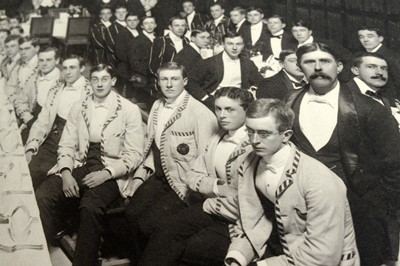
left=14, top=47, right=61, bottom=143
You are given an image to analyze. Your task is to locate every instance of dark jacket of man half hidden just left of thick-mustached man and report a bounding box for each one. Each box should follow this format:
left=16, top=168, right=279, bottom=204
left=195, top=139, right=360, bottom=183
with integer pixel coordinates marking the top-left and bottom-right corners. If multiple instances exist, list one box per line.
left=256, top=70, right=295, bottom=102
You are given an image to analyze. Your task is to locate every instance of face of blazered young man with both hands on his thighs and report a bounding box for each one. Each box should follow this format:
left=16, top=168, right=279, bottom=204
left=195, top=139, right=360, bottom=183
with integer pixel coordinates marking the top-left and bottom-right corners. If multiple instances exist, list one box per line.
left=90, top=70, right=117, bottom=99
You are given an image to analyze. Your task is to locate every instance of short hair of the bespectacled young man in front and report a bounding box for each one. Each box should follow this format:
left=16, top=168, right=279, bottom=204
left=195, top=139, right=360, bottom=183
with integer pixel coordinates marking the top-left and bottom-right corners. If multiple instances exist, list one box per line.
left=246, top=98, right=294, bottom=132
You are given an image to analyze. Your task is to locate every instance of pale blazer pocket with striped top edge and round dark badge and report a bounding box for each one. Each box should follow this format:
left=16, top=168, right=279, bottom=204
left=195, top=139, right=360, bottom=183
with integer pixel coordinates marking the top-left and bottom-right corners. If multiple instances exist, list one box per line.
left=170, top=131, right=197, bottom=162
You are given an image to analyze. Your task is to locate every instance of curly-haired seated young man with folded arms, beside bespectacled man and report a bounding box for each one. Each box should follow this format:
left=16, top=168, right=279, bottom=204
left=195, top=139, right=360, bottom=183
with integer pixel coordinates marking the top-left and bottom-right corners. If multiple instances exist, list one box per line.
left=139, top=87, right=254, bottom=266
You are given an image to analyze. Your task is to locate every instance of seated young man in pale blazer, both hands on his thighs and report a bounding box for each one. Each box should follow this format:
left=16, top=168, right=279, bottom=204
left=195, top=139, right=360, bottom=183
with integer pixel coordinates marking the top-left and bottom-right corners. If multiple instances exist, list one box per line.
left=36, top=64, right=144, bottom=266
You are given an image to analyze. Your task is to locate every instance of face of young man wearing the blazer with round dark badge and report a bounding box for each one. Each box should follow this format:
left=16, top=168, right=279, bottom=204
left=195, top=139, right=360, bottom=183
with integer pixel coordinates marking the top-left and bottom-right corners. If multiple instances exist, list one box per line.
left=158, top=69, right=187, bottom=103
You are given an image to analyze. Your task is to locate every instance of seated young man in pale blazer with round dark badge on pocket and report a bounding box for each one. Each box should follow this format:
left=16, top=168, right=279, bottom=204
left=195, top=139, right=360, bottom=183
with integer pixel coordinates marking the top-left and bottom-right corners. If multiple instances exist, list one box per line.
left=126, top=62, right=218, bottom=261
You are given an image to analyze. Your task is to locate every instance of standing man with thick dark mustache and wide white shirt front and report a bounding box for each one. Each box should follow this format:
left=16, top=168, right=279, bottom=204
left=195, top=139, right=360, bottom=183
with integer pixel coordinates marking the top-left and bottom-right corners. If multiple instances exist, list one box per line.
left=288, top=43, right=400, bottom=265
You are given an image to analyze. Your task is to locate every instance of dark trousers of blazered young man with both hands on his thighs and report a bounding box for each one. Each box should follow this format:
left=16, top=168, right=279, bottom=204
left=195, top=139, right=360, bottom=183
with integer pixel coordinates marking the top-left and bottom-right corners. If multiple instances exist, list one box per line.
left=36, top=143, right=120, bottom=266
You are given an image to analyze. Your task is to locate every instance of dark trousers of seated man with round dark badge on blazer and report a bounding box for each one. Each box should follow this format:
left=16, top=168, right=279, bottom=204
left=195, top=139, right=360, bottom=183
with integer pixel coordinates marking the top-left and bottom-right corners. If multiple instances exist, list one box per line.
left=126, top=175, right=187, bottom=261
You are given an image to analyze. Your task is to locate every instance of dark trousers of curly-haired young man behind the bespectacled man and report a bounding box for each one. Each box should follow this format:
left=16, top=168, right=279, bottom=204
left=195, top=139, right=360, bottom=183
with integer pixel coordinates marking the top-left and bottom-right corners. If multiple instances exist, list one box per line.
left=139, top=203, right=231, bottom=266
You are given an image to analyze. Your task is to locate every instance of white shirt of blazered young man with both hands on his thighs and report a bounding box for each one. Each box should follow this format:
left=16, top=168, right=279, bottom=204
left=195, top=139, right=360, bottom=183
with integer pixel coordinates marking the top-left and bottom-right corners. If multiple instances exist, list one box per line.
left=89, top=97, right=110, bottom=143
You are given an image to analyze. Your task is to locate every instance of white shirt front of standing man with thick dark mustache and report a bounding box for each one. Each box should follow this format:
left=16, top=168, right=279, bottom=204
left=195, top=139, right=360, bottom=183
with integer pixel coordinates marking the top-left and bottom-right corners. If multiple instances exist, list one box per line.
left=299, top=82, right=340, bottom=151
